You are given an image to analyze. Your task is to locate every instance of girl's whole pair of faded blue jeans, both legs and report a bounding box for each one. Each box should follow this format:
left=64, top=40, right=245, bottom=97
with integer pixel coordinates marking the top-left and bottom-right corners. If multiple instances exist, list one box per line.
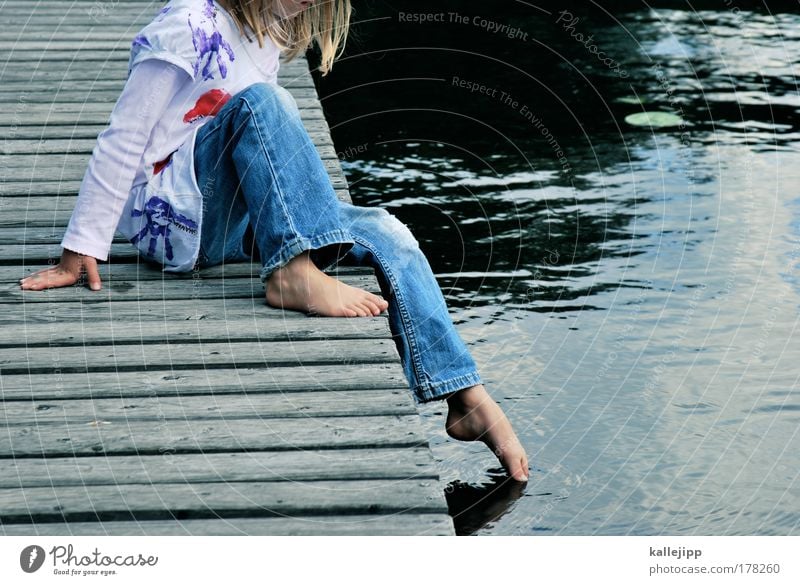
left=194, top=83, right=481, bottom=402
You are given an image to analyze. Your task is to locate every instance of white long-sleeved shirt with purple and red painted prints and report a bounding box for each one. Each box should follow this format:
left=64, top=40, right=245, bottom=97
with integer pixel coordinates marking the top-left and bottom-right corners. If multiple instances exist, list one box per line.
left=61, top=0, right=280, bottom=271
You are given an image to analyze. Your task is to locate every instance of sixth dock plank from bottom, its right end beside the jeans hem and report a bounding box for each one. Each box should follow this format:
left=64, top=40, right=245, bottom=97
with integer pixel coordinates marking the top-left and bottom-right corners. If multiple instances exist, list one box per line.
left=0, top=363, right=408, bottom=401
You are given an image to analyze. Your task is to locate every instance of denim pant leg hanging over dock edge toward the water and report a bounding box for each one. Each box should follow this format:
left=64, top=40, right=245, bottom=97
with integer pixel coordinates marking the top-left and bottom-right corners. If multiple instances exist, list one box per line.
left=339, top=203, right=481, bottom=402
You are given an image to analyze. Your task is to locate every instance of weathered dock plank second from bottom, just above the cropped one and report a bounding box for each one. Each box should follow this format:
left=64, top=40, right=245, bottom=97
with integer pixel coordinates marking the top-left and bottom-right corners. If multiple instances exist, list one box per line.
left=0, top=479, right=445, bottom=523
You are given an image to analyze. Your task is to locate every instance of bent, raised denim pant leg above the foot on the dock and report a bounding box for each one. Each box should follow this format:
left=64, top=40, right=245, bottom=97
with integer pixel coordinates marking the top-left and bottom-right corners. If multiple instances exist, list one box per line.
left=194, top=83, right=353, bottom=281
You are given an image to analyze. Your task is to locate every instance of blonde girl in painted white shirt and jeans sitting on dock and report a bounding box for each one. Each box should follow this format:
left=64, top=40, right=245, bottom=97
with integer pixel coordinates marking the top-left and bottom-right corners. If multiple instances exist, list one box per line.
left=20, top=0, right=528, bottom=481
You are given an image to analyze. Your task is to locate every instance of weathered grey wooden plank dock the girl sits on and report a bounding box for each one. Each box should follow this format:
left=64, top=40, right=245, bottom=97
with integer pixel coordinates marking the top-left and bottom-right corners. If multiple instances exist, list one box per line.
left=0, top=0, right=453, bottom=535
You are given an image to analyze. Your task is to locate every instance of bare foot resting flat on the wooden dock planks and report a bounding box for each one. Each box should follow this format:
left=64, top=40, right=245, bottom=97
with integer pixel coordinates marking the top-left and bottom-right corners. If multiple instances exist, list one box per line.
left=267, top=252, right=389, bottom=317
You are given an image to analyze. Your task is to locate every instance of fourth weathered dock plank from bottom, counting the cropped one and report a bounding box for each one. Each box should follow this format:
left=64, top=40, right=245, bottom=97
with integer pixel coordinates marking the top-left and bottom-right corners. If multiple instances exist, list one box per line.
left=0, top=415, right=427, bottom=458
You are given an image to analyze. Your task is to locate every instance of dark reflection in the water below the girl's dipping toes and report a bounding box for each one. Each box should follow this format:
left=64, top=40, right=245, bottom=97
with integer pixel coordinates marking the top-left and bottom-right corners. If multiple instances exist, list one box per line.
left=444, top=470, right=525, bottom=536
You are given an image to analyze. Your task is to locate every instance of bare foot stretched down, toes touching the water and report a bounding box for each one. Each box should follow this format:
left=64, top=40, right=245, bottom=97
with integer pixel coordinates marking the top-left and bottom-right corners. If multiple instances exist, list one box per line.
left=446, top=384, right=528, bottom=481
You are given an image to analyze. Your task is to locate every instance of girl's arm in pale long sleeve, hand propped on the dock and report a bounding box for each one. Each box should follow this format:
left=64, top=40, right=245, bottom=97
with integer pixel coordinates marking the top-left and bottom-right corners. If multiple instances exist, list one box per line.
left=20, top=59, right=191, bottom=290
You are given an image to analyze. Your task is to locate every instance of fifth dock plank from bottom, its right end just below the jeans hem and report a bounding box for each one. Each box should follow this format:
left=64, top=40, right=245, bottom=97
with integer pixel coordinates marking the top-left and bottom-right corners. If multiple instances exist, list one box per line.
left=0, top=388, right=417, bottom=428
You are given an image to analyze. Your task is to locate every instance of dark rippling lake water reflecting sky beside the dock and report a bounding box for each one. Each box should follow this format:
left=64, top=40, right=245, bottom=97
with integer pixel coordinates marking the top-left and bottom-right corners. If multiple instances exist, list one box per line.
left=312, top=2, right=800, bottom=535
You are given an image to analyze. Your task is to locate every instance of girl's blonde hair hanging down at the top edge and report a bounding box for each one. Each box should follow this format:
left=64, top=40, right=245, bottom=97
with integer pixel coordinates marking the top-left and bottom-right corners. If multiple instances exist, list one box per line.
left=217, top=0, right=352, bottom=75
